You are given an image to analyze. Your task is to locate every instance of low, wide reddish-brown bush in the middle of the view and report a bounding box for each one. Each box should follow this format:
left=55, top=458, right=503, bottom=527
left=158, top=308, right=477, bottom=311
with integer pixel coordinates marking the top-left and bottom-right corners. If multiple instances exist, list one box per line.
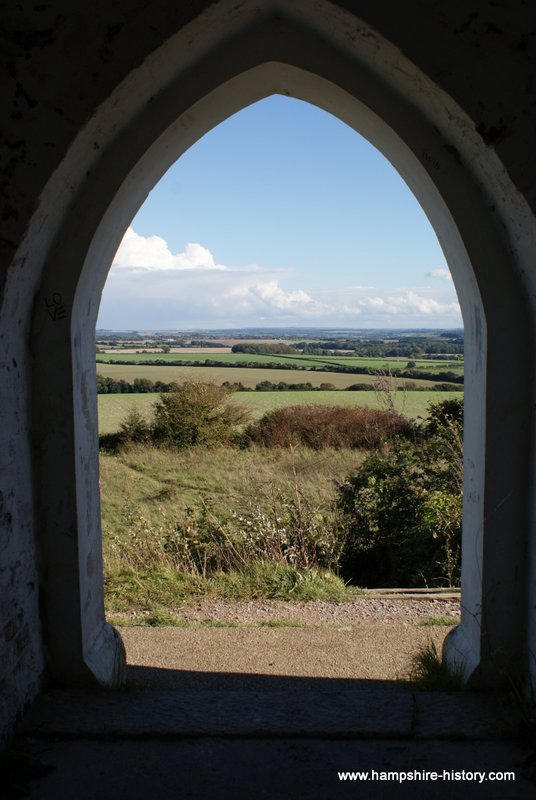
left=246, top=405, right=413, bottom=450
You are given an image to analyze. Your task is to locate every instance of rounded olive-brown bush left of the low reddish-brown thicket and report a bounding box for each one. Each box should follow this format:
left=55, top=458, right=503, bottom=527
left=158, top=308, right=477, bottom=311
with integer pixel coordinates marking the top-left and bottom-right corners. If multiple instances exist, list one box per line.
left=152, top=380, right=249, bottom=448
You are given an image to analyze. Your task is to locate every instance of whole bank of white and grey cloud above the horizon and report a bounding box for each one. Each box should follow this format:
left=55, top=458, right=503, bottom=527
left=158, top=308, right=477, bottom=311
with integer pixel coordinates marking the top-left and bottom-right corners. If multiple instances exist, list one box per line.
left=98, top=228, right=461, bottom=329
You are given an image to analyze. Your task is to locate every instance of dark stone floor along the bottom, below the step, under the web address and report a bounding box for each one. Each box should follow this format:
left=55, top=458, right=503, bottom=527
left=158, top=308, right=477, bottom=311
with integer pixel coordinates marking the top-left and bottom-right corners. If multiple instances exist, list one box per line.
left=19, top=738, right=534, bottom=800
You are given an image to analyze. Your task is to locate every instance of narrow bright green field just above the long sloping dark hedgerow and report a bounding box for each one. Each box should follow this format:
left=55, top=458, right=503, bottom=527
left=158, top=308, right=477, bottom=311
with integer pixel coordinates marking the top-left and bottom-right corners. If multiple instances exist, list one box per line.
left=97, top=352, right=463, bottom=375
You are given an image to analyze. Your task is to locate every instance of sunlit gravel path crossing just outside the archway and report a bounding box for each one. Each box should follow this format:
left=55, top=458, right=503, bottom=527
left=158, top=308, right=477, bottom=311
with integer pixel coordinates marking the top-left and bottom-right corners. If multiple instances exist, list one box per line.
left=117, top=597, right=459, bottom=688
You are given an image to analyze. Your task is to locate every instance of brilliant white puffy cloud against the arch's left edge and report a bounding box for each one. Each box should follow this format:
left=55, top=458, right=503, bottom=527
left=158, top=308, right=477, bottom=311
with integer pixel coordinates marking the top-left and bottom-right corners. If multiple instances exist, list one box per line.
left=113, top=228, right=227, bottom=271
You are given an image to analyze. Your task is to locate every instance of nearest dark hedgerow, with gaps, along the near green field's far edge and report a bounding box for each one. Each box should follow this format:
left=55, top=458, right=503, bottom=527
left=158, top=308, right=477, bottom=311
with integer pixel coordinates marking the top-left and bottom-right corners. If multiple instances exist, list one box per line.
left=97, top=375, right=463, bottom=394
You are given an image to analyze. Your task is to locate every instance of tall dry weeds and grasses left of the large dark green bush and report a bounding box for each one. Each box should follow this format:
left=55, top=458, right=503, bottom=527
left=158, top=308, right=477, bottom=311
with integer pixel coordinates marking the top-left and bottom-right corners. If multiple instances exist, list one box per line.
left=103, top=496, right=343, bottom=578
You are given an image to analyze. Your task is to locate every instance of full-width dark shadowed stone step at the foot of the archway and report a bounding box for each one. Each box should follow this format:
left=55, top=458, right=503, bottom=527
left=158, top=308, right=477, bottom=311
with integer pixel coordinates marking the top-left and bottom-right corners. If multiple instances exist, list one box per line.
left=22, top=679, right=520, bottom=740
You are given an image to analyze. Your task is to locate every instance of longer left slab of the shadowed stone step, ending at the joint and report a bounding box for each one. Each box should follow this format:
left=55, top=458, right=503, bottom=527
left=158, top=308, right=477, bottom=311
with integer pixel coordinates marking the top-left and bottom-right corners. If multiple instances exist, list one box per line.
left=23, top=689, right=413, bottom=738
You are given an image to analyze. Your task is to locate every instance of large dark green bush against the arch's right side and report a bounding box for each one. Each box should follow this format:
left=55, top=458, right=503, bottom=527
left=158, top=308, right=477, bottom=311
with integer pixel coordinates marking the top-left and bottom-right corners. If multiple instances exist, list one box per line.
left=339, top=400, right=463, bottom=586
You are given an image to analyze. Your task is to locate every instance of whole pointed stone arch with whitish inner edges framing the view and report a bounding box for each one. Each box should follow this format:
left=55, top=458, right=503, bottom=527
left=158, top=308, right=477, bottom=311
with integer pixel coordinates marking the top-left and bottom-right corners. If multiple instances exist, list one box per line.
left=19, top=0, right=536, bottom=685
